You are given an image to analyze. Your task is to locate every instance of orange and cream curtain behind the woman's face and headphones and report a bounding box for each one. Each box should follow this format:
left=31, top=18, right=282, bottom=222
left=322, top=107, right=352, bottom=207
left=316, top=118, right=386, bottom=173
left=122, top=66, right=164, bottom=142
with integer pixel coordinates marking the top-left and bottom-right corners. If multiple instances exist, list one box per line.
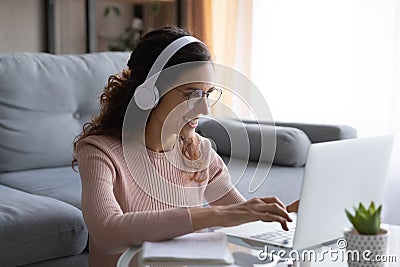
left=182, top=0, right=253, bottom=116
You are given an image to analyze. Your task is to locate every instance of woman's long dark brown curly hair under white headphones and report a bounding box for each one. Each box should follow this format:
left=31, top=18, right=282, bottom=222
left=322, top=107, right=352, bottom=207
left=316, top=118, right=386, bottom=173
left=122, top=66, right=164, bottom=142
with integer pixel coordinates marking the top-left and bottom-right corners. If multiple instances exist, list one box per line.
left=72, top=27, right=211, bottom=181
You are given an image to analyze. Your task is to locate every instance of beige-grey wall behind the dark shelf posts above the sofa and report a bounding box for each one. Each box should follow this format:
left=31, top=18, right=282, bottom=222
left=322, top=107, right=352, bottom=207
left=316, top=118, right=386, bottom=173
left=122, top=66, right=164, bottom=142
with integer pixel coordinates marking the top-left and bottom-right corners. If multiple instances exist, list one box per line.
left=0, top=0, right=176, bottom=54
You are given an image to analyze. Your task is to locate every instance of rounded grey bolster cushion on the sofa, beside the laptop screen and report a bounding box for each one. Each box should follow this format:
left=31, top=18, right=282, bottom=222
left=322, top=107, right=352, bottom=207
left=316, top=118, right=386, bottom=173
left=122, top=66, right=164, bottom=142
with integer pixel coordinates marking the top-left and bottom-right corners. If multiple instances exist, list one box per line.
left=197, top=118, right=311, bottom=167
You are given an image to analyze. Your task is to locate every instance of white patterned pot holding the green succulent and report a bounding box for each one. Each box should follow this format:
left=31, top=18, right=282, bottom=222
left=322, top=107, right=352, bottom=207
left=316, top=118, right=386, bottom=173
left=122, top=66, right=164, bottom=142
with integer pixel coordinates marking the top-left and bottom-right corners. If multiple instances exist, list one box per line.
left=344, top=229, right=389, bottom=267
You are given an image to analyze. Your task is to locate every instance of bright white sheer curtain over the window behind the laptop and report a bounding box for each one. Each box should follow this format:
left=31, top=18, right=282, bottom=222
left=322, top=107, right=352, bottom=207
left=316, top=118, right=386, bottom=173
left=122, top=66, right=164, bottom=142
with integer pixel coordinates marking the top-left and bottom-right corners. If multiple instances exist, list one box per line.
left=250, top=0, right=400, bottom=224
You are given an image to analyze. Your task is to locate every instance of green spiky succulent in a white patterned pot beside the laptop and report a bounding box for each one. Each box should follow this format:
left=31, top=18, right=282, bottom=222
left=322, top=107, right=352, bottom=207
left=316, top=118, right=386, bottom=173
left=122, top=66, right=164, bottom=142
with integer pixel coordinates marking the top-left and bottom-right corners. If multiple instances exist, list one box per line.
left=344, top=201, right=389, bottom=267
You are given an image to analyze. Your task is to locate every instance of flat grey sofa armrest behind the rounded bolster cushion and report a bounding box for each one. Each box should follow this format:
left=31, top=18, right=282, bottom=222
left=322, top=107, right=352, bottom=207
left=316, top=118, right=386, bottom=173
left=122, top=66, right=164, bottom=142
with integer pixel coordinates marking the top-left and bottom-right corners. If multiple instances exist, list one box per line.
left=243, top=120, right=357, bottom=143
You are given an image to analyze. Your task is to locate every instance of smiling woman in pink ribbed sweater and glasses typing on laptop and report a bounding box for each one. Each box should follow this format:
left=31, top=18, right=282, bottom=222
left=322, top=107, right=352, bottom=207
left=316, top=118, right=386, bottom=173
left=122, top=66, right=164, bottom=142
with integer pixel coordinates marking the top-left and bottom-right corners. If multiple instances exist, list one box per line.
left=73, top=27, right=295, bottom=266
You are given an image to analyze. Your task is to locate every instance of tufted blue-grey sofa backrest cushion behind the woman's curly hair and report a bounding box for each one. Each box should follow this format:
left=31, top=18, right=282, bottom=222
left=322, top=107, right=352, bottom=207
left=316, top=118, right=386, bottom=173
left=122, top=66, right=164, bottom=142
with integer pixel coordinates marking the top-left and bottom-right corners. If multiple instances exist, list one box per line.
left=0, top=52, right=130, bottom=172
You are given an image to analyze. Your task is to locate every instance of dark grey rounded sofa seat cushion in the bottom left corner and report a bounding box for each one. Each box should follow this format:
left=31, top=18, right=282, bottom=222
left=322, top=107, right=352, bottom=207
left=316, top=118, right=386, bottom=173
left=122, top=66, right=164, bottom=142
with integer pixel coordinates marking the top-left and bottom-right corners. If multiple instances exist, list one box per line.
left=0, top=185, right=88, bottom=266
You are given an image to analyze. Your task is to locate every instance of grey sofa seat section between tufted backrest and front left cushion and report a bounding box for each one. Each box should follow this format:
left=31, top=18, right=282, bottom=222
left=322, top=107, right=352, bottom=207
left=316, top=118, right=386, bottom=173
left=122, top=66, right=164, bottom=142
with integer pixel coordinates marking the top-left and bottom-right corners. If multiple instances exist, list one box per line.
left=0, top=167, right=82, bottom=209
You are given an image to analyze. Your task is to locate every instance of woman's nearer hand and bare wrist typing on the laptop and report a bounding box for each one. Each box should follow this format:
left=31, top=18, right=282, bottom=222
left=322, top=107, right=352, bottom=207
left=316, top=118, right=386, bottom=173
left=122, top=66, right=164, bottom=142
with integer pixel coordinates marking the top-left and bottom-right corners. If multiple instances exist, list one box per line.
left=190, top=197, right=292, bottom=231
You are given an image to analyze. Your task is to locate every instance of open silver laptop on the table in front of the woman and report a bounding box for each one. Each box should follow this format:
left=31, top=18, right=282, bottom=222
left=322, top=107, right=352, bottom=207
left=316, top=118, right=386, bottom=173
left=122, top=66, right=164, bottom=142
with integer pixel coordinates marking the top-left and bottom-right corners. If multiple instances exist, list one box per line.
left=216, top=135, right=394, bottom=250
